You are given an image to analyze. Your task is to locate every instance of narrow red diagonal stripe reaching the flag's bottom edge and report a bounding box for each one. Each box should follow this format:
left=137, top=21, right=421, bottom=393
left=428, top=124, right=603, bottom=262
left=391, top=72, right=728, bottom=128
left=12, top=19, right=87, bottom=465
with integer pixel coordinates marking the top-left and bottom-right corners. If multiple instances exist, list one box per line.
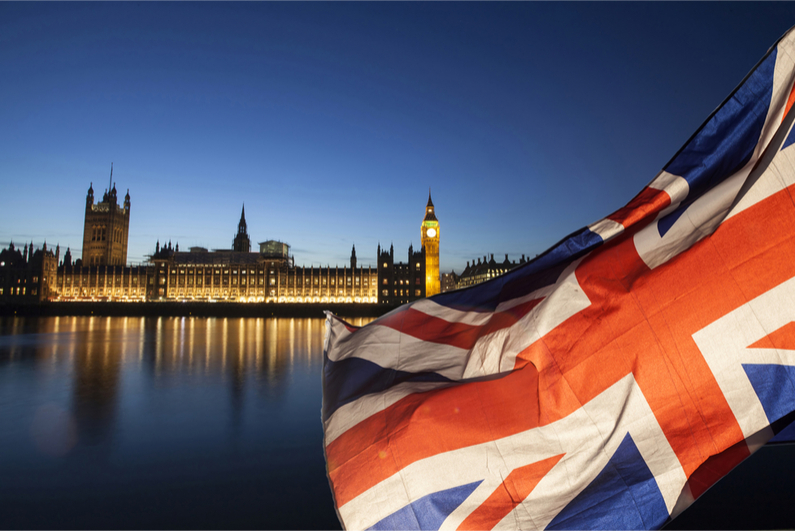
left=458, top=454, right=566, bottom=531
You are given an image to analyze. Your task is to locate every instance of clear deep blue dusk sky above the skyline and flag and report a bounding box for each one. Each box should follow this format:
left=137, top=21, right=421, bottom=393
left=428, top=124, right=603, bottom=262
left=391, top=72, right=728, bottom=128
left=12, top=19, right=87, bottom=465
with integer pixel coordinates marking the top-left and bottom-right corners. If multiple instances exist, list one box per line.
left=0, top=2, right=795, bottom=272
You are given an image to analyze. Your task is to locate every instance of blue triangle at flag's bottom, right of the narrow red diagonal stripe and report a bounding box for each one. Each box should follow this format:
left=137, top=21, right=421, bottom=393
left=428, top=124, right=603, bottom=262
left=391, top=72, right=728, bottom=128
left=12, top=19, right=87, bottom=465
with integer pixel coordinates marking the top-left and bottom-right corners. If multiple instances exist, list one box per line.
left=547, top=433, right=668, bottom=529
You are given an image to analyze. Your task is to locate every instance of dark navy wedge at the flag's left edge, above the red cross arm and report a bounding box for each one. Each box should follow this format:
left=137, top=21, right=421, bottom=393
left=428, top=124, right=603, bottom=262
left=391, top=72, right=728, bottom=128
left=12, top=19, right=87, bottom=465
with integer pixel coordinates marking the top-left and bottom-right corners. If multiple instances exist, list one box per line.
left=323, top=357, right=451, bottom=420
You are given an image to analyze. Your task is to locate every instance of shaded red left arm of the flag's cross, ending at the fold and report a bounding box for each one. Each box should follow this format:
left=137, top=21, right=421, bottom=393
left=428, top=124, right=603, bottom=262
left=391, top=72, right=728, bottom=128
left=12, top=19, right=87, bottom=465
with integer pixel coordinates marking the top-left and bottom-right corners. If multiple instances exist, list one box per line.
left=326, top=365, right=538, bottom=506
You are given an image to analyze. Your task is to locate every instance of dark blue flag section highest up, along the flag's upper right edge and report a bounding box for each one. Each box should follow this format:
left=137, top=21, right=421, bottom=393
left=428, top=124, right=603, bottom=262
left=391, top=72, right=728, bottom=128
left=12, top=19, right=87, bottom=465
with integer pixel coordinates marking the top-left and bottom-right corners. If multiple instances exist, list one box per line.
left=665, top=49, right=778, bottom=203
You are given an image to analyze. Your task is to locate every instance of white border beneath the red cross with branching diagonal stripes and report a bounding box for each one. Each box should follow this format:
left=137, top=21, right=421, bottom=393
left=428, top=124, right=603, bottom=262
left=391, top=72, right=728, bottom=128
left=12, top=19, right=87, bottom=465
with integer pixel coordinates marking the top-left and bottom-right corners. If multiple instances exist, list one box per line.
left=339, top=374, right=686, bottom=529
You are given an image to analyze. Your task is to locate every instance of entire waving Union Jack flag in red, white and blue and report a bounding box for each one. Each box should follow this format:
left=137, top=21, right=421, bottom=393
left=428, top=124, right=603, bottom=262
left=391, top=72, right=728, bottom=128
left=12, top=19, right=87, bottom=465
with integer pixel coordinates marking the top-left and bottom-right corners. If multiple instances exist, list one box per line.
left=322, top=27, right=795, bottom=529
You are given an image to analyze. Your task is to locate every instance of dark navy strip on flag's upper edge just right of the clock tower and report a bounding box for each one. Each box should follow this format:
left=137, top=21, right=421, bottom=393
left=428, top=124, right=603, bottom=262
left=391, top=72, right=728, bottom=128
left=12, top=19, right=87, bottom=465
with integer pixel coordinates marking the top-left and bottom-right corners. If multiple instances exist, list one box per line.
left=433, top=228, right=604, bottom=312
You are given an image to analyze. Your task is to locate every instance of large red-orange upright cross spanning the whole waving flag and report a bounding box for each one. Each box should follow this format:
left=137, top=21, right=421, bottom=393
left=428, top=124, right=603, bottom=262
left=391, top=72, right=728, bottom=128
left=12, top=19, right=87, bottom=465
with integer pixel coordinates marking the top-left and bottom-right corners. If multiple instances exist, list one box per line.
left=326, top=187, right=795, bottom=506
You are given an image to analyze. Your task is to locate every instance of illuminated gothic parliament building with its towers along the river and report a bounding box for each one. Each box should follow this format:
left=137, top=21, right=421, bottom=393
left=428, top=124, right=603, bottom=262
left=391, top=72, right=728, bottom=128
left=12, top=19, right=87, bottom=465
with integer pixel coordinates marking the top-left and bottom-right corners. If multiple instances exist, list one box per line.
left=0, top=175, right=440, bottom=305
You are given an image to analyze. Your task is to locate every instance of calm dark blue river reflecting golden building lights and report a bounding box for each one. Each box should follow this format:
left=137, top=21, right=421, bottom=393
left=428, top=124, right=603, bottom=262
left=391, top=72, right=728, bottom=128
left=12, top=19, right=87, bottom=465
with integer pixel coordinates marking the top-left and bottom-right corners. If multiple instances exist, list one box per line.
left=0, top=317, right=795, bottom=529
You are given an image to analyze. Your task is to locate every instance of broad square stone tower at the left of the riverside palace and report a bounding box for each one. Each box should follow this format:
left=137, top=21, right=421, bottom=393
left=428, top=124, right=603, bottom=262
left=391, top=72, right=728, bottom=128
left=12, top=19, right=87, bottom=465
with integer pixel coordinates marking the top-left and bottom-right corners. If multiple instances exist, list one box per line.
left=83, top=165, right=130, bottom=266
